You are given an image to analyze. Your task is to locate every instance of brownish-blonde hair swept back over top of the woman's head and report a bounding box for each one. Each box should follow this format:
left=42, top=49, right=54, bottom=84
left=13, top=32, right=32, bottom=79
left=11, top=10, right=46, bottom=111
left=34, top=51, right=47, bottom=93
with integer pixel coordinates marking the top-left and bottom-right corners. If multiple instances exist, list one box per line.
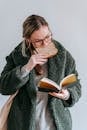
left=23, top=15, right=48, bottom=38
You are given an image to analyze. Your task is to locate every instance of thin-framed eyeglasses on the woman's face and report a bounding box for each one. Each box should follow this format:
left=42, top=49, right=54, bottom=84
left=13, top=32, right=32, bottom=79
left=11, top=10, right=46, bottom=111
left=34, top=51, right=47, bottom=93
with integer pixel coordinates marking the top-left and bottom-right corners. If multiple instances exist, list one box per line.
left=31, top=34, right=52, bottom=47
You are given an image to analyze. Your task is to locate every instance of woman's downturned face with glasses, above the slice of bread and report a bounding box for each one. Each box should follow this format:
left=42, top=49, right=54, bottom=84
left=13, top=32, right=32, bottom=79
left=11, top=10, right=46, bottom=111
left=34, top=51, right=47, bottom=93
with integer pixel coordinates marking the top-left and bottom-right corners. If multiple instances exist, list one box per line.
left=27, top=26, right=52, bottom=48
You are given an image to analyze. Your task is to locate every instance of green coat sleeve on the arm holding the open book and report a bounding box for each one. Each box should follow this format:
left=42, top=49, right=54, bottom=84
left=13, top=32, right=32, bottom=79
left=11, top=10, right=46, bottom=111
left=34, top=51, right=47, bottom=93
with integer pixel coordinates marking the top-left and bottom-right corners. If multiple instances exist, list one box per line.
left=63, top=52, right=81, bottom=107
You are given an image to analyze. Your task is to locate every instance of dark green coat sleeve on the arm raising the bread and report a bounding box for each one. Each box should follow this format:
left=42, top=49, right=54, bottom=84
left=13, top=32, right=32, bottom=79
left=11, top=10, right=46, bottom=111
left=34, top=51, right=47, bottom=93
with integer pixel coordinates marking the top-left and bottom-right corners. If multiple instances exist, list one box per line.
left=0, top=53, right=29, bottom=95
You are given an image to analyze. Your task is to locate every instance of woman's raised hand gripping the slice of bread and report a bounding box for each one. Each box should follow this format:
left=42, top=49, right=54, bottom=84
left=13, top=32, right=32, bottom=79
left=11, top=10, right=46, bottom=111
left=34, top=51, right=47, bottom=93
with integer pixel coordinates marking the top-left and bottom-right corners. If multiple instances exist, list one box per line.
left=24, top=54, right=47, bottom=71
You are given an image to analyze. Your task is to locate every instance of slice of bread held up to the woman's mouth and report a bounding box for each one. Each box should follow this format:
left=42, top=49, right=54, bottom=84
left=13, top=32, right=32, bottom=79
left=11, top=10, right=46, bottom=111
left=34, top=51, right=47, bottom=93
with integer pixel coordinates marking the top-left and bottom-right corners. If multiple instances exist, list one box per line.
left=36, top=43, right=58, bottom=58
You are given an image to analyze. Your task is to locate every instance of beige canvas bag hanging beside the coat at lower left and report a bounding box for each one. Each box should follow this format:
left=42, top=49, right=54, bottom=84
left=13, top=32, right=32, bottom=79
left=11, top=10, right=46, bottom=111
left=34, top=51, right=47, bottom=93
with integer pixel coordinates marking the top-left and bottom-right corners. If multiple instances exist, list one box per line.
left=0, top=91, right=18, bottom=130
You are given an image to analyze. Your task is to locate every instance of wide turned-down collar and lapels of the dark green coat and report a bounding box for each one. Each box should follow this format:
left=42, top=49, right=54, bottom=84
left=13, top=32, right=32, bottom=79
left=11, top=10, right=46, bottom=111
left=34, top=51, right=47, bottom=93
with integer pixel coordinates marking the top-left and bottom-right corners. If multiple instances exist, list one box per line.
left=13, top=40, right=66, bottom=83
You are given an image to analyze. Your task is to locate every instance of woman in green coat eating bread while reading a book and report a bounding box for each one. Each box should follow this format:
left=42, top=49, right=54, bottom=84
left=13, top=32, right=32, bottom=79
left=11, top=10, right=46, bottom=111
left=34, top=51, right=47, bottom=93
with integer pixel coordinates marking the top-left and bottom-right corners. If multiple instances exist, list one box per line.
left=0, top=15, right=81, bottom=130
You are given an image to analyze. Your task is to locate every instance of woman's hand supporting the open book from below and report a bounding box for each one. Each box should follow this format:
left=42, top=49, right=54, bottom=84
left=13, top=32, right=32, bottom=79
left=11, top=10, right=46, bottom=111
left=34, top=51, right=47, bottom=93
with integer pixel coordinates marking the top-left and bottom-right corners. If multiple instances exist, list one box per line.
left=49, top=89, right=70, bottom=100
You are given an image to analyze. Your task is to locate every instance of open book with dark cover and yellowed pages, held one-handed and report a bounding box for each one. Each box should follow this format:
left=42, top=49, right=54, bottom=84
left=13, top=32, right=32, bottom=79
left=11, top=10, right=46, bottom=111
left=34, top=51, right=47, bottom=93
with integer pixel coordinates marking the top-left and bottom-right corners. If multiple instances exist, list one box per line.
left=38, top=74, right=77, bottom=92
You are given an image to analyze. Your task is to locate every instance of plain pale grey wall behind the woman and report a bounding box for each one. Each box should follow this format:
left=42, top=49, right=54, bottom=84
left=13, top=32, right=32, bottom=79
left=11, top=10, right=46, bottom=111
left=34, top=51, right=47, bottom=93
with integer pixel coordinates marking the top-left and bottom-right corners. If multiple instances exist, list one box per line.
left=0, top=0, right=87, bottom=130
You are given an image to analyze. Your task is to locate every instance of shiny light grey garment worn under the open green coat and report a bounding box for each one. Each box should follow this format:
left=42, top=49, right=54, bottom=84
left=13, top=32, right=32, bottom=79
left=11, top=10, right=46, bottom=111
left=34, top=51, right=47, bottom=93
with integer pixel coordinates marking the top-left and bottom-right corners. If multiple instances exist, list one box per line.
left=35, top=63, right=55, bottom=130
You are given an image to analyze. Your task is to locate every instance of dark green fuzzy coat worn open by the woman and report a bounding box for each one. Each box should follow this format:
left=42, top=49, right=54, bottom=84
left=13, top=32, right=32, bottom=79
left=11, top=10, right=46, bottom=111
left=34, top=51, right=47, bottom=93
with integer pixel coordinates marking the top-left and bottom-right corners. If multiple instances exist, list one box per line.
left=0, top=40, right=81, bottom=130
